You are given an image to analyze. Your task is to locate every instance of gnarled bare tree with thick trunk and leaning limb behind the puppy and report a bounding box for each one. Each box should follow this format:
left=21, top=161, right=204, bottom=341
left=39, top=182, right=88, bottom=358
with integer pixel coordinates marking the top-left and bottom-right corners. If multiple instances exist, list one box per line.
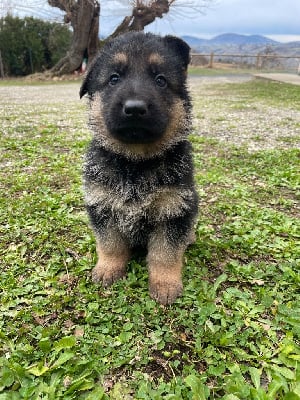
left=48, top=0, right=213, bottom=75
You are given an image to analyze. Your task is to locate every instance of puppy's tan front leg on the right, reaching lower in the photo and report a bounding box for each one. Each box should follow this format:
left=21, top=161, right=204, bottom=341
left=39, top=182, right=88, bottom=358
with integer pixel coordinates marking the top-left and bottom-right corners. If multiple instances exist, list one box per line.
left=147, top=232, right=185, bottom=305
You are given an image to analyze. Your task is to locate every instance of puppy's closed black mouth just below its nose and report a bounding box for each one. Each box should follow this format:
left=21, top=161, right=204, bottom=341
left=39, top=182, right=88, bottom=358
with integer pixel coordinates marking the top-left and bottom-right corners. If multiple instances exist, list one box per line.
left=111, top=123, right=163, bottom=144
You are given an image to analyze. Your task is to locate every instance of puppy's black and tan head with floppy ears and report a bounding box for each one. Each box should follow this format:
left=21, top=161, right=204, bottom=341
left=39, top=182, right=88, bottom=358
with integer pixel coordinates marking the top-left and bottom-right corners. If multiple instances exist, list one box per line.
left=80, top=33, right=190, bottom=157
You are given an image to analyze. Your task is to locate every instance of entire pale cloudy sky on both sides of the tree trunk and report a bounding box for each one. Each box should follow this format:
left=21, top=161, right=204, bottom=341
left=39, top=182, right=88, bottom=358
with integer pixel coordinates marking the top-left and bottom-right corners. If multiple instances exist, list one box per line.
left=5, top=0, right=300, bottom=42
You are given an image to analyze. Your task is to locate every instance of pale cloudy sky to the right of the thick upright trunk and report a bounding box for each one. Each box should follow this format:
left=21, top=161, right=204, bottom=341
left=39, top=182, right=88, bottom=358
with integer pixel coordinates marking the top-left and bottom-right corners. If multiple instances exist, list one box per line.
left=100, top=0, right=300, bottom=42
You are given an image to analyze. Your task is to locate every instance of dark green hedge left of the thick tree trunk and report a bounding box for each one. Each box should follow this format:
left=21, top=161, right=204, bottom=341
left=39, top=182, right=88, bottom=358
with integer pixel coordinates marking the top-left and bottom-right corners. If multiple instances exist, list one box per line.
left=0, top=15, right=72, bottom=76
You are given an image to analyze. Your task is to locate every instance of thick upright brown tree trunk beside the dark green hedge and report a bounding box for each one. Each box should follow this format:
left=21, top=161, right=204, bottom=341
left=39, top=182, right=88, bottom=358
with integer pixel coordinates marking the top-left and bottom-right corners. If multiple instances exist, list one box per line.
left=48, top=0, right=100, bottom=75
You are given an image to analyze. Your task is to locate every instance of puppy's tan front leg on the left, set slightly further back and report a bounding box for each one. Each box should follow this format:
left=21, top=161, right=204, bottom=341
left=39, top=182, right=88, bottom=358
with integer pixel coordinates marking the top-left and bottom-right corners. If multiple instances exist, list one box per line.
left=92, top=236, right=130, bottom=287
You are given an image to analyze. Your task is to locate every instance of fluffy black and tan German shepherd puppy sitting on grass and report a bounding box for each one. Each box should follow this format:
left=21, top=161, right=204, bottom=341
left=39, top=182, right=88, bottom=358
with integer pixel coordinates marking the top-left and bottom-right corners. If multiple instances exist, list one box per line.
left=80, top=32, right=198, bottom=305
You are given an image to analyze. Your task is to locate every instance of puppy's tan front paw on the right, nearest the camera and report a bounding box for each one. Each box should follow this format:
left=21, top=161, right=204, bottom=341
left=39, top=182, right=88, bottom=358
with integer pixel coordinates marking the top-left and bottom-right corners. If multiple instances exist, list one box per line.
left=149, top=278, right=183, bottom=305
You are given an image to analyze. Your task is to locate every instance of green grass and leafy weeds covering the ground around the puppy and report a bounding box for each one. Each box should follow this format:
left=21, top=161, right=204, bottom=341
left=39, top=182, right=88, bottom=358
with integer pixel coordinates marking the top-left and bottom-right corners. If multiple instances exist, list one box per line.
left=0, top=82, right=300, bottom=400
